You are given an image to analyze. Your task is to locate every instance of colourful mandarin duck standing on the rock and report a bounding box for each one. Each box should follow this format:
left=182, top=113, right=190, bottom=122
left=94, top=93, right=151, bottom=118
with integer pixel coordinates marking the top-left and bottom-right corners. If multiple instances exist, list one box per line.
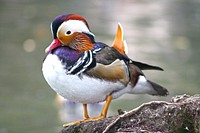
left=42, top=14, right=168, bottom=127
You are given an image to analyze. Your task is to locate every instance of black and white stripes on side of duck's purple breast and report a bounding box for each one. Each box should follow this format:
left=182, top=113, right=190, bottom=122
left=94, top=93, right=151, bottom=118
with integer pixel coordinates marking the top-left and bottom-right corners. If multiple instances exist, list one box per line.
left=66, top=50, right=96, bottom=75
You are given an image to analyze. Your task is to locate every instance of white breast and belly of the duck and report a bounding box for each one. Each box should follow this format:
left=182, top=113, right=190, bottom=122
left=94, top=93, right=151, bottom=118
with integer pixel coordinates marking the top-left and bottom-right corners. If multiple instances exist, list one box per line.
left=42, top=54, right=125, bottom=103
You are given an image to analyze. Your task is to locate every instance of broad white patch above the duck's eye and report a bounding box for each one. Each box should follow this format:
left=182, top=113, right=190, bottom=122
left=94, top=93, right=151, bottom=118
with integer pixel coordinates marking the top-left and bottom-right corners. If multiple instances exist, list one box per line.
left=57, top=20, right=89, bottom=35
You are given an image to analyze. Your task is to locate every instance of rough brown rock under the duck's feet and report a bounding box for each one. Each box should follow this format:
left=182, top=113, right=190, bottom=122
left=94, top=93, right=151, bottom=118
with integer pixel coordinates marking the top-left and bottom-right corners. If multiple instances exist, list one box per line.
left=60, top=95, right=200, bottom=133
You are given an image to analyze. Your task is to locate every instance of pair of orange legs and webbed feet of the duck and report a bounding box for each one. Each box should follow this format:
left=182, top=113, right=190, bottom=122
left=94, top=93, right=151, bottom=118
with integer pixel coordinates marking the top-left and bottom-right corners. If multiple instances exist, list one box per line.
left=63, top=96, right=112, bottom=127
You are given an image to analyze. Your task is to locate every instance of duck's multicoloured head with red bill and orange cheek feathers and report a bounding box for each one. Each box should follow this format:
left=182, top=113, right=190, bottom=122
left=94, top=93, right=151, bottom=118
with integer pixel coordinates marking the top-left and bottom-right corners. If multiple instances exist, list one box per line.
left=45, top=14, right=94, bottom=52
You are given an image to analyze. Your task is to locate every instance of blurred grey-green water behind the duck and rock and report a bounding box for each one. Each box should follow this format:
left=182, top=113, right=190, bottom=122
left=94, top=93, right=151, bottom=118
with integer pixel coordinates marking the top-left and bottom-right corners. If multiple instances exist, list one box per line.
left=0, top=0, right=200, bottom=133
